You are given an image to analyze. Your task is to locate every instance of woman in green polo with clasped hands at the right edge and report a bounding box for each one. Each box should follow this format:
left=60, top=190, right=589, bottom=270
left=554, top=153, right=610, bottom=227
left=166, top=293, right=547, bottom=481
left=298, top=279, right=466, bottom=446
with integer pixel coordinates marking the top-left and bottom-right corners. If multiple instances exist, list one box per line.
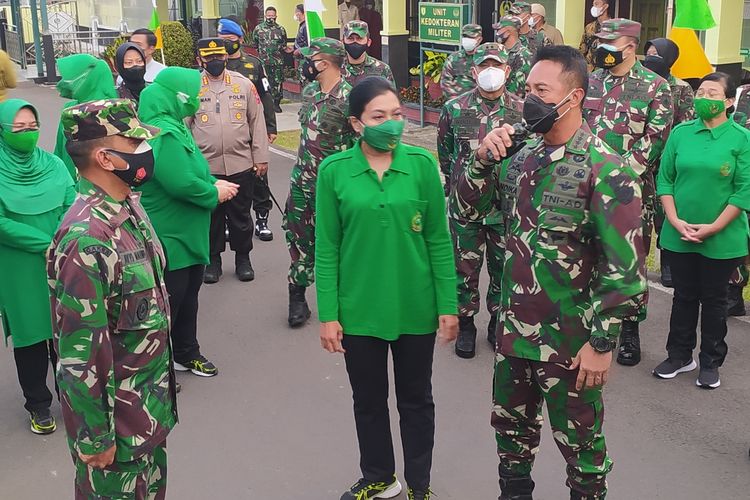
left=653, top=73, right=750, bottom=389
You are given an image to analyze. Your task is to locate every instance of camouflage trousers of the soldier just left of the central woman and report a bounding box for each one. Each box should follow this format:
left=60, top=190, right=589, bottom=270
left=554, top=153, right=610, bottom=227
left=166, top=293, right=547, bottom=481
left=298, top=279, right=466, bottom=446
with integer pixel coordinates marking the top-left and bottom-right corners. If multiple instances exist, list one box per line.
left=281, top=165, right=317, bottom=287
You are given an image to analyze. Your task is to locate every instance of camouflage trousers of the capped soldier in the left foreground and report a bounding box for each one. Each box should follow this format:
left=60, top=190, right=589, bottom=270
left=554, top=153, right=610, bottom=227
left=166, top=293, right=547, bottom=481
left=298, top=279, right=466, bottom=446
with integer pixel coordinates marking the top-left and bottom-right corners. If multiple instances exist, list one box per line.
left=73, top=441, right=167, bottom=500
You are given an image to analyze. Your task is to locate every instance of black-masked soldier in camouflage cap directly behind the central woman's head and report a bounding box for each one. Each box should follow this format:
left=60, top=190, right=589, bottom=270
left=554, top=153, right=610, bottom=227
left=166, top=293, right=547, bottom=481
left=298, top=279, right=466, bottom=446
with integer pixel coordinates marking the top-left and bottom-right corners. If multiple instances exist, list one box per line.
left=342, top=21, right=396, bottom=88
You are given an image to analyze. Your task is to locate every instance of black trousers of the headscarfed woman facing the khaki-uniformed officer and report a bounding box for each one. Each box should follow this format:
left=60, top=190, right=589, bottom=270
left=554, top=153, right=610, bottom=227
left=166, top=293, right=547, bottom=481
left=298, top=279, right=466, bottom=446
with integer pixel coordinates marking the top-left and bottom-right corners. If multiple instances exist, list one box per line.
left=164, top=265, right=204, bottom=363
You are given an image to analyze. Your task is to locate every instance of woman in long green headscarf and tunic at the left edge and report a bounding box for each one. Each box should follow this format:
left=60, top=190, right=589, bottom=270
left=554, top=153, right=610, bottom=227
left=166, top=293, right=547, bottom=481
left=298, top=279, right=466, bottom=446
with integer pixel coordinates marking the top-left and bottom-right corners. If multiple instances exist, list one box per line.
left=0, top=99, right=75, bottom=434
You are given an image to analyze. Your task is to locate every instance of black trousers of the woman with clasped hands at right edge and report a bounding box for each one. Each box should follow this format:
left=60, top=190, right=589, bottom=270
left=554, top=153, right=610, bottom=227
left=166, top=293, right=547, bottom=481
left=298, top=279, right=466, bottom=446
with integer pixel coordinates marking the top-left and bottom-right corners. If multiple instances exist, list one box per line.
left=665, top=251, right=742, bottom=368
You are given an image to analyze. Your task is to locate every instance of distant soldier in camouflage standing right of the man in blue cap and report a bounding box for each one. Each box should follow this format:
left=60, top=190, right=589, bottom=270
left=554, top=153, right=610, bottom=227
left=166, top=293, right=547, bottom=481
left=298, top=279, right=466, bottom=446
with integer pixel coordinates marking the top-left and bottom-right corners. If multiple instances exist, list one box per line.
left=252, top=7, right=286, bottom=113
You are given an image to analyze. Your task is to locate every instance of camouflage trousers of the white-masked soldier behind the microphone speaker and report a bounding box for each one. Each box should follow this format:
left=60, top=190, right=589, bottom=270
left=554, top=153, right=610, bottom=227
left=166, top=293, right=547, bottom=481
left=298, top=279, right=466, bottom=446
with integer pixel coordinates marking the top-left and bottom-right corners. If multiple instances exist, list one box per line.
left=448, top=217, right=505, bottom=316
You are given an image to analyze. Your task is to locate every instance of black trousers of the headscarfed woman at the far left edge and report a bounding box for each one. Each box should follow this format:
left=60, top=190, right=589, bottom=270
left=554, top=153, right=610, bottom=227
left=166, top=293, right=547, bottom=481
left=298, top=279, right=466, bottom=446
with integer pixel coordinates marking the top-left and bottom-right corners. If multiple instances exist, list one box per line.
left=13, top=340, right=59, bottom=412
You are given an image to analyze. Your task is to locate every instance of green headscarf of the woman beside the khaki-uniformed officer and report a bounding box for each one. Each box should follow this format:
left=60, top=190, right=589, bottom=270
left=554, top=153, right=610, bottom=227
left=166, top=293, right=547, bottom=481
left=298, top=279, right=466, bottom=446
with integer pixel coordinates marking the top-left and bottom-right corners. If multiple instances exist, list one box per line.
left=138, top=66, right=201, bottom=152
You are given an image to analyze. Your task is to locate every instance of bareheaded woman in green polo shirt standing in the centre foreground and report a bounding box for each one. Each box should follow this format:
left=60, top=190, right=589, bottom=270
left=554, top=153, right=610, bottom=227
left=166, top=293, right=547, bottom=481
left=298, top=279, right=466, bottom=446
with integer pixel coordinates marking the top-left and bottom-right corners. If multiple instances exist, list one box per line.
left=315, top=77, right=458, bottom=500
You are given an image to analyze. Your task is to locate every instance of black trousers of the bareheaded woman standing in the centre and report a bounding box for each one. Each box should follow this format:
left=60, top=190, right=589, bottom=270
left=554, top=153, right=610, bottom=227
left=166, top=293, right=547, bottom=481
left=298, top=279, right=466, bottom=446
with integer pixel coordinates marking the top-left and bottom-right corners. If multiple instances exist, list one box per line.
left=343, top=333, right=435, bottom=489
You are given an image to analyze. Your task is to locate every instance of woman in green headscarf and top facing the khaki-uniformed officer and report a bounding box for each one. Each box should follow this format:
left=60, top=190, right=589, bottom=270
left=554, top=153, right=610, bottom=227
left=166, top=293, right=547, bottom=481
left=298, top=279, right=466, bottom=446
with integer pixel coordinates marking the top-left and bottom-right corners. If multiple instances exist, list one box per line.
left=138, top=67, right=237, bottom=377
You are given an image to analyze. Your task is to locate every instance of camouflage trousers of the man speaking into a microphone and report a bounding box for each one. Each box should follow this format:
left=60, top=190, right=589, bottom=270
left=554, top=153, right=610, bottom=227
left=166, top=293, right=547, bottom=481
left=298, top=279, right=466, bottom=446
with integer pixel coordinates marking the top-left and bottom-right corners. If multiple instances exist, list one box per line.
left=491, top=353, right=612, bottom=499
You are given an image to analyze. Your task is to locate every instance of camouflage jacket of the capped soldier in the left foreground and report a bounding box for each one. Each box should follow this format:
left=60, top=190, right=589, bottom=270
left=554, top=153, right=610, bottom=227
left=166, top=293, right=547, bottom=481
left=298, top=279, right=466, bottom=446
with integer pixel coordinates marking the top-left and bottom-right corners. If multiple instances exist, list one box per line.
left=47, top=179, right=177, bottom=462
